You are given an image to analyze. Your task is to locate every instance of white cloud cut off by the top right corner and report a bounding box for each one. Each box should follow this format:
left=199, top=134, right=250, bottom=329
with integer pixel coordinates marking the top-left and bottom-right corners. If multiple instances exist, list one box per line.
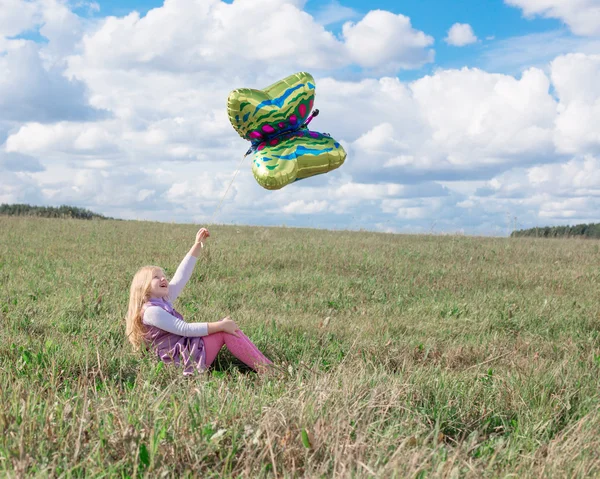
left=504, top=0, right=600, bottom=36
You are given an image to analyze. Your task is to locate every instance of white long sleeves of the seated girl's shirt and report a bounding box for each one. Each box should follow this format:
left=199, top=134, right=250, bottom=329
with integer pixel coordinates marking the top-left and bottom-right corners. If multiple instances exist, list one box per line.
left=143, top=254, right=208, bottom=337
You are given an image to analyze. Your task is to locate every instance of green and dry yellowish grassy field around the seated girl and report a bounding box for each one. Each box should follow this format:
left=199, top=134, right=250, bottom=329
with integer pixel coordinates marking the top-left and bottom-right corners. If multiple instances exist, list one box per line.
left=0, top=217, right=600, bottom=478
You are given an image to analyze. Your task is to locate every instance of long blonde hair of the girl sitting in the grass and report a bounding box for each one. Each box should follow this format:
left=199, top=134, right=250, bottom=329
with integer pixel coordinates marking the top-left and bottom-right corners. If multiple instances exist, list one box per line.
left=125, top=266, right=162, bottom=351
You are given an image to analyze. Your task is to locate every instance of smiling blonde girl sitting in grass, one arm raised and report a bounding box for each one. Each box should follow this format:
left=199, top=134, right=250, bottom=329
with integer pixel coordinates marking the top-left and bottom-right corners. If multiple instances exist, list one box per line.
left=126, top=228, right=272, bottom=375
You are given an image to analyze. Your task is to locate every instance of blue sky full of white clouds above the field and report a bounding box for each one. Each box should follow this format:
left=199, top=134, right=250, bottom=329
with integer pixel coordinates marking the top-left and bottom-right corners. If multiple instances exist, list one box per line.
left=0, top=0, right=600, bottom=235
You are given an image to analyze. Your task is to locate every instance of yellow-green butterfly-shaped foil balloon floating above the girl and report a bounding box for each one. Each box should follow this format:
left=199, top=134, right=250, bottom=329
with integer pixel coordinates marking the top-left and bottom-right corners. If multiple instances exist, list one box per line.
left=227, top=72, right=346, bottom=190
